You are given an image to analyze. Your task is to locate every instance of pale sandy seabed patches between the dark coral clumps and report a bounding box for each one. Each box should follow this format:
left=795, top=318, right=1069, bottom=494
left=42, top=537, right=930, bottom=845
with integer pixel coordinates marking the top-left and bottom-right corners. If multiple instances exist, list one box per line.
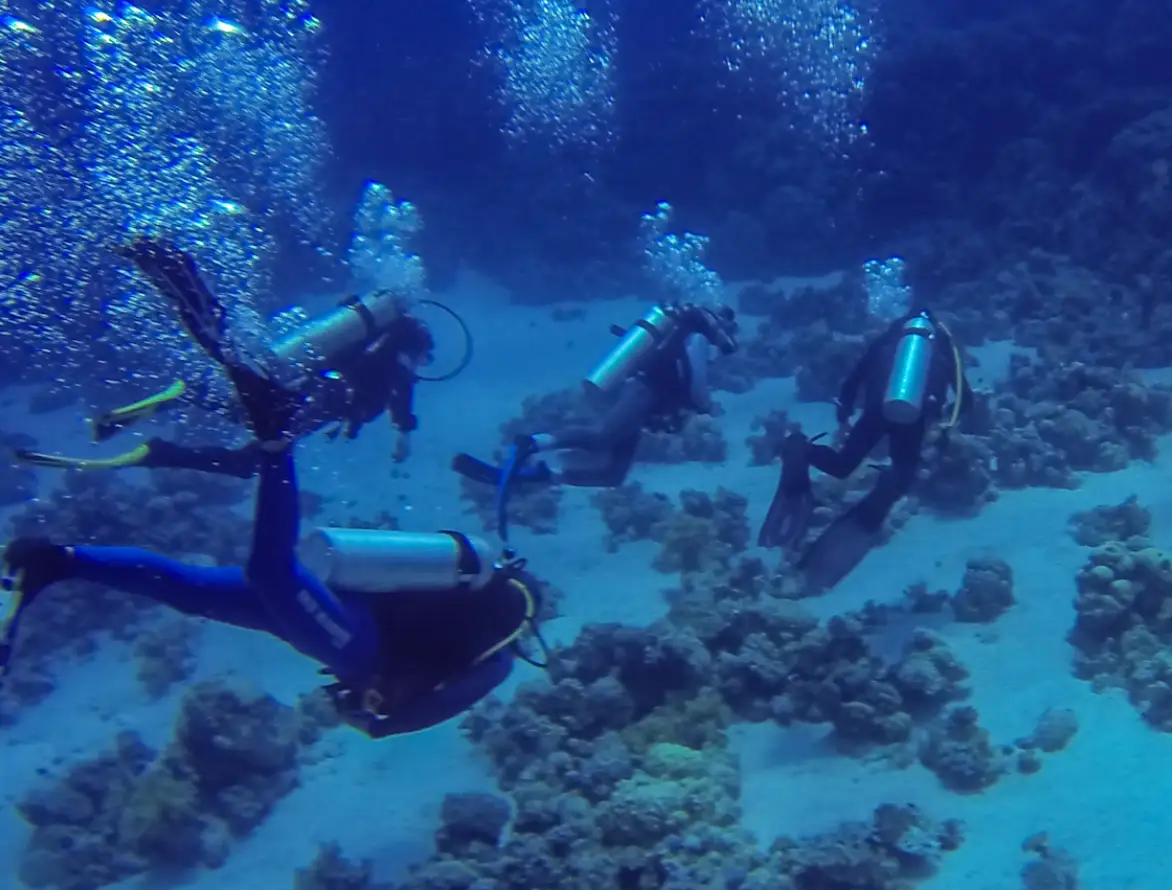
left=0, top=288, right=1172, bottom=890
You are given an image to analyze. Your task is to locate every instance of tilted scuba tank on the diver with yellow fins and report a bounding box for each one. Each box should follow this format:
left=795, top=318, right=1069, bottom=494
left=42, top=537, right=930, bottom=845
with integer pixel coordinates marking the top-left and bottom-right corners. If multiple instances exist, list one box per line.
left=273, top=291, right=403, bottom=371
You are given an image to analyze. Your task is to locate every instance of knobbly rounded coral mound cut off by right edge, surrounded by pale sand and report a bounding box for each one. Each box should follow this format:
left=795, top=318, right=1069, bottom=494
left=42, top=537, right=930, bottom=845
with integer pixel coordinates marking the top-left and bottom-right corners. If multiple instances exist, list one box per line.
left=1069, top=538, right=1172, bottom=732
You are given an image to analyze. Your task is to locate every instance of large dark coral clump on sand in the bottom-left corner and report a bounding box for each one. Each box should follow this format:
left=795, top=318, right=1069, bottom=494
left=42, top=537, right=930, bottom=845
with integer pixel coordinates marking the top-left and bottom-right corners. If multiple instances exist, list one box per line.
left=18, top=682, right=300, bottom=890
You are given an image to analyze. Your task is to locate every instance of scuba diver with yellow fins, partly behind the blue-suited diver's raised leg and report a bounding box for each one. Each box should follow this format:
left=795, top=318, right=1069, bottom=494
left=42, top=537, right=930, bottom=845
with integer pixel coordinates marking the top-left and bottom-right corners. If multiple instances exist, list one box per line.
left=15, top=238, right=435, bottom=478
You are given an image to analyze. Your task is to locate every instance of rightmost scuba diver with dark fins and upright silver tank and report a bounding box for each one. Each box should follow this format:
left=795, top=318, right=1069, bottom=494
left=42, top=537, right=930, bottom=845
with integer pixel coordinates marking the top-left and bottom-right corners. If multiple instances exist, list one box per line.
left=757, top=310, right=973, bottom=590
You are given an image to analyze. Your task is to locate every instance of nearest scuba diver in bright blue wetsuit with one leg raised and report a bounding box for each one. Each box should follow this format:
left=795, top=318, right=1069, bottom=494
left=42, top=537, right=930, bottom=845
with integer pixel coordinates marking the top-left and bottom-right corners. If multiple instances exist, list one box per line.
left=0, top=254, right=546, bottom=738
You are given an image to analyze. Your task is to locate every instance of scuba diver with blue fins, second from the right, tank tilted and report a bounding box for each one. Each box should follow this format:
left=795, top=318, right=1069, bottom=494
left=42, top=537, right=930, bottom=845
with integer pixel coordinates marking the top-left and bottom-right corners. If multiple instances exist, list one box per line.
left=452, top=304, right=737, bottom=504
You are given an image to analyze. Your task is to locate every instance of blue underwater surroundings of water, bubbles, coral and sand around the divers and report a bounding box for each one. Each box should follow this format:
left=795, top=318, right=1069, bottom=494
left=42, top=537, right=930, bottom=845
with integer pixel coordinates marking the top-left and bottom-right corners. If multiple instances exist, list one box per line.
left=0, top=0, right=1172, bottom=890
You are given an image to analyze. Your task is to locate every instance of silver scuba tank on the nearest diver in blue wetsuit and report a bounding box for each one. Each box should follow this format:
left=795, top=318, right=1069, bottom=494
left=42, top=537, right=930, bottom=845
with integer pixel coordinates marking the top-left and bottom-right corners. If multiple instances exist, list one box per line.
left=301, top=528, right=495, bottom=593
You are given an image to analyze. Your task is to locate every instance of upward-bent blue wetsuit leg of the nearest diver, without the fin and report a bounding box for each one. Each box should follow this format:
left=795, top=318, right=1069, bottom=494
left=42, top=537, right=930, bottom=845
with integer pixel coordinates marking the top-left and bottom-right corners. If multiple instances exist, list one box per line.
left=245, top=446, right=377, bottom=674
